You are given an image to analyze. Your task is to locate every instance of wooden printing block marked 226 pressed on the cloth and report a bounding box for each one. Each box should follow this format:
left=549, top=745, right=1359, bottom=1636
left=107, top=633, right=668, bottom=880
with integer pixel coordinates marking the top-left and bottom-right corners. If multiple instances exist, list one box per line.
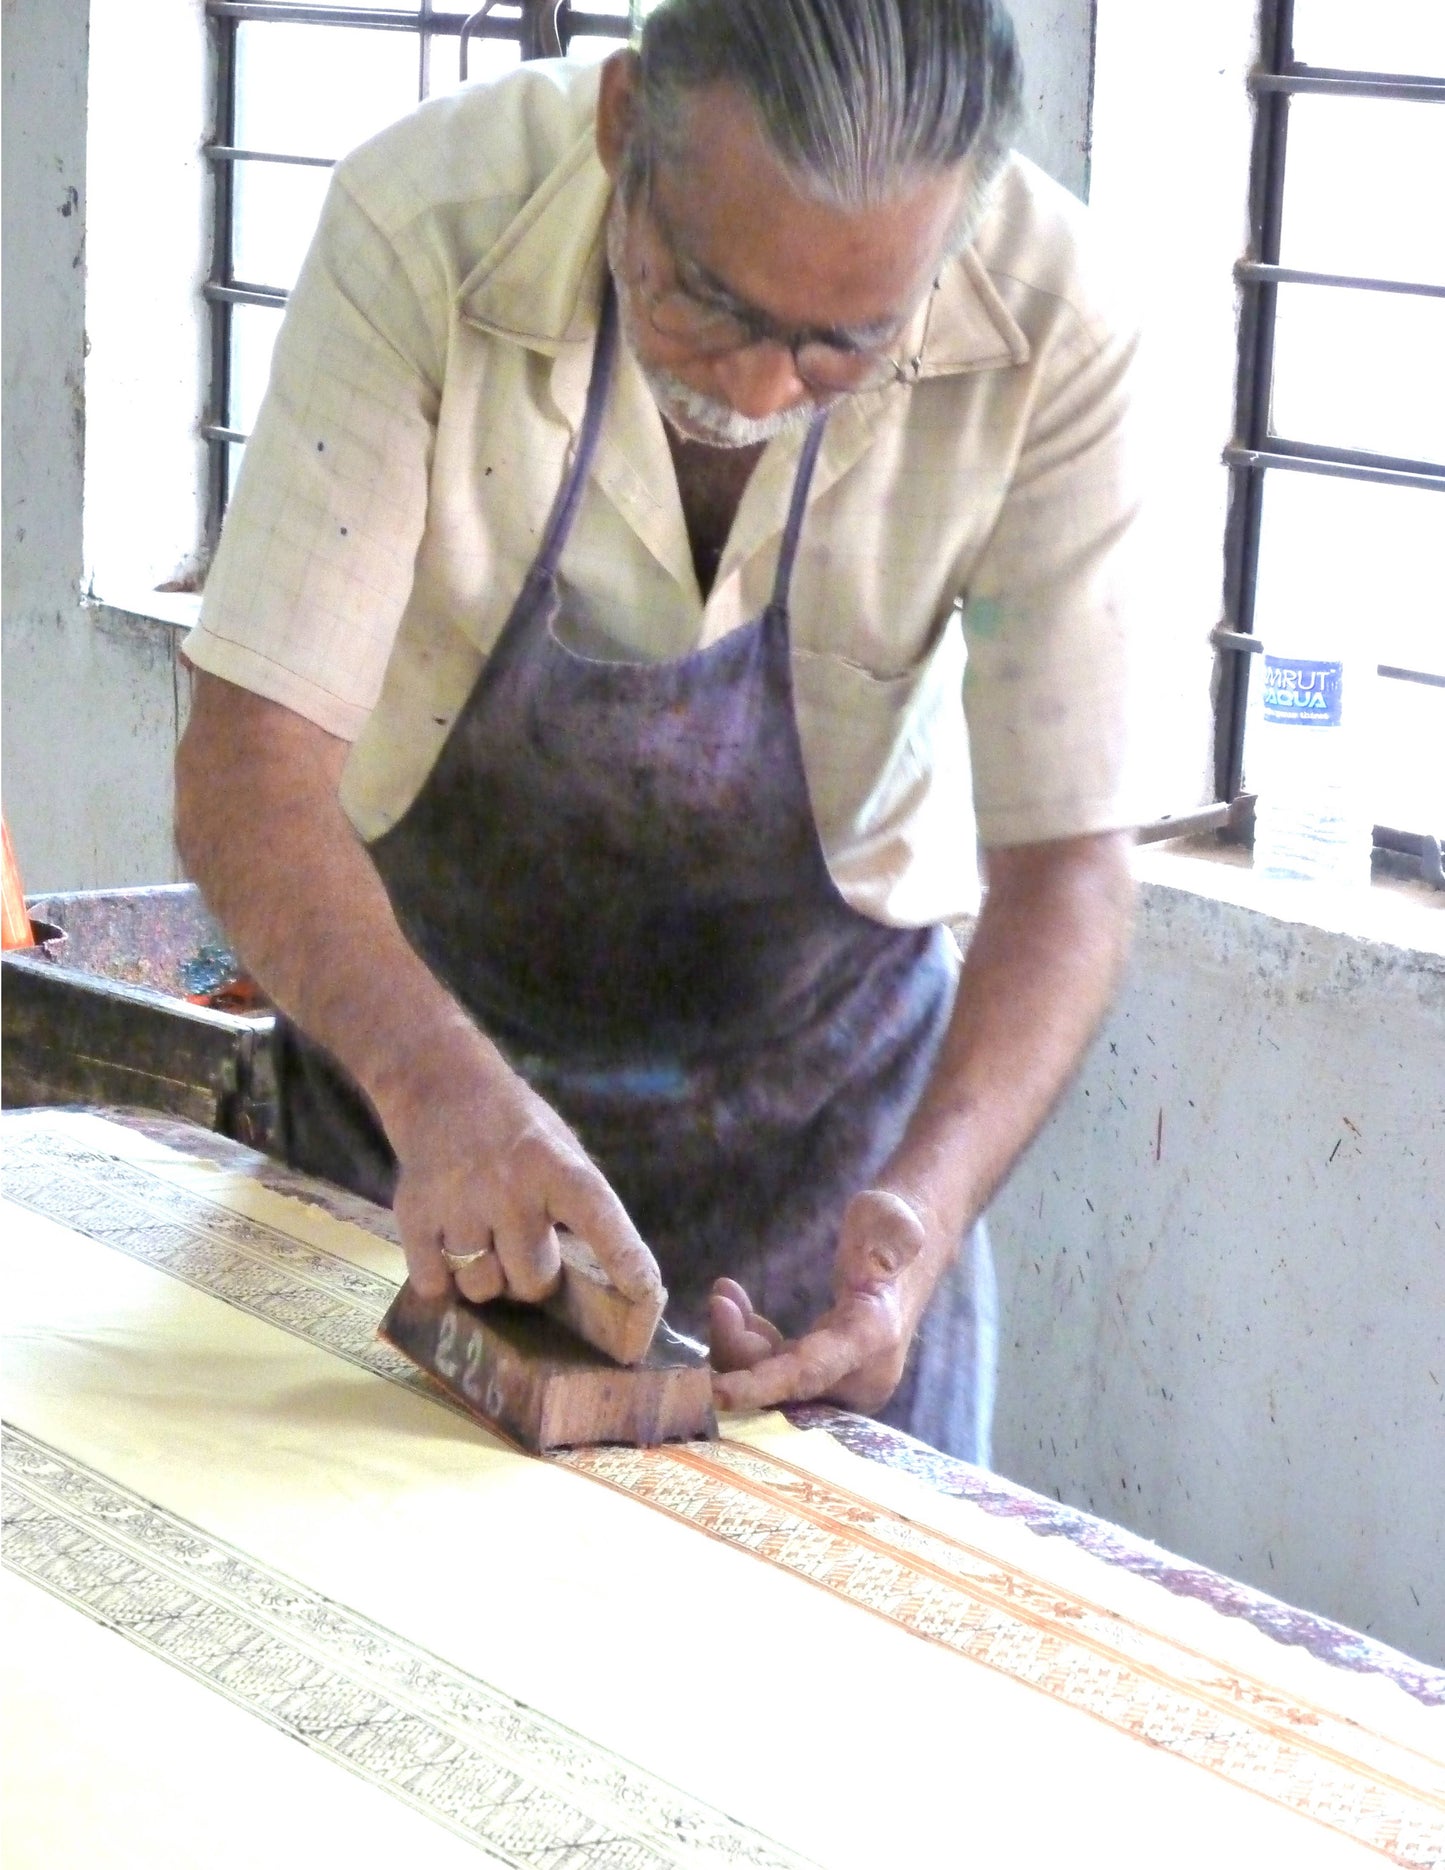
left=379, top=1283, right=718, bottom=1455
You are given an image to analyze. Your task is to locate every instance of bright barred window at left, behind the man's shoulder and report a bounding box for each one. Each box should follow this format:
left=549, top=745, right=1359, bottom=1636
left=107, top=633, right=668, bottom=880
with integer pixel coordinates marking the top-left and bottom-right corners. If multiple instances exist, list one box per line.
left=202, top=0, right=645, bottom=548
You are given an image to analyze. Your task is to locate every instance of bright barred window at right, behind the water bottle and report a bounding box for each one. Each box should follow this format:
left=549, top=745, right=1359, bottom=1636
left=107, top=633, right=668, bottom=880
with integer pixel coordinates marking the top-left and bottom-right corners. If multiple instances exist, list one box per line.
left=1215, top=0, right=1445, bottom=886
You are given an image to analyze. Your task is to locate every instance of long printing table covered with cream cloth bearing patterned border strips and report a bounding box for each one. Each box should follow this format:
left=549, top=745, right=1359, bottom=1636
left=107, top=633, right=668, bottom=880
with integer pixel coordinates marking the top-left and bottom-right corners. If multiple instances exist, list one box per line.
left=0, top=1111, right=1445, bottom=1870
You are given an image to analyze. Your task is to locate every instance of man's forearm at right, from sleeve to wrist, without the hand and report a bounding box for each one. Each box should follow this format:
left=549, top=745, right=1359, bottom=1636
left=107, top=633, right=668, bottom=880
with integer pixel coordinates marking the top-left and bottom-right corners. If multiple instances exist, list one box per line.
left=880, top=832, right=1133, bottom=1242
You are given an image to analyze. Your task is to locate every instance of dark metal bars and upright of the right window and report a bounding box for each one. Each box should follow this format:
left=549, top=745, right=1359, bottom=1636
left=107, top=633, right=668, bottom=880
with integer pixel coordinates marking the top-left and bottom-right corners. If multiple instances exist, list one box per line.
left=1211, top=0, right=1445, bottom=886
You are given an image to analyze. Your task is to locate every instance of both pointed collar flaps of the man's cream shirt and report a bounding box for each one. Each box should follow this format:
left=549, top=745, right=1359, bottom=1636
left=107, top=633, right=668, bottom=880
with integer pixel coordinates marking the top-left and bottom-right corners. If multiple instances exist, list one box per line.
left=456, top=106, right=1028, bottom=378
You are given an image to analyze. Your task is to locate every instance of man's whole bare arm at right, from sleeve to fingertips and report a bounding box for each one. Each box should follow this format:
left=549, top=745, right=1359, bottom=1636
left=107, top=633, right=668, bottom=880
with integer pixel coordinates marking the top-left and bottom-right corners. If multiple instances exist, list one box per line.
left=710, top=832, right=1133, bottom=1410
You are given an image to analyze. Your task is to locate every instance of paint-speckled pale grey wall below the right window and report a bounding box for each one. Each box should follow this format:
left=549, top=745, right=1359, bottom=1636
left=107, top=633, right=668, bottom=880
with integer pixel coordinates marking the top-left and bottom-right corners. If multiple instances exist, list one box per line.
left=994, top=885, right=1445, bottom=1666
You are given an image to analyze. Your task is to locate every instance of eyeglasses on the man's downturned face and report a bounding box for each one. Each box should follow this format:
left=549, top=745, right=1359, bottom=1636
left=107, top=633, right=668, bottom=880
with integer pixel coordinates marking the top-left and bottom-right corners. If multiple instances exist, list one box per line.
left=636, top=189, right=922, bottom=396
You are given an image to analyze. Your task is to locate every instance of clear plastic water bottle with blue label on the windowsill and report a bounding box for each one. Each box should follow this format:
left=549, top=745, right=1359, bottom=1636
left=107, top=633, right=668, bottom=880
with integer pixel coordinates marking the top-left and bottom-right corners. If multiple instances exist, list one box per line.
left=1249, top=638, right=1374, bottom=888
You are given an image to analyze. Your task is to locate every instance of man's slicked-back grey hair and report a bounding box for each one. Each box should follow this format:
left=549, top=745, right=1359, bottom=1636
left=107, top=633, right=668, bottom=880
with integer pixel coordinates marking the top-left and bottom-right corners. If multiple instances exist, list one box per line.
left=628, top=0, right=1023, bottom=219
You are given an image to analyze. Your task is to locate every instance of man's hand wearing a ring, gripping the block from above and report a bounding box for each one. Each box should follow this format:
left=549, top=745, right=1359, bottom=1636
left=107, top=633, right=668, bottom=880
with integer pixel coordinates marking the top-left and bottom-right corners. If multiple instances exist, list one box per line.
left=381, top=1036, right=662, bottom=1303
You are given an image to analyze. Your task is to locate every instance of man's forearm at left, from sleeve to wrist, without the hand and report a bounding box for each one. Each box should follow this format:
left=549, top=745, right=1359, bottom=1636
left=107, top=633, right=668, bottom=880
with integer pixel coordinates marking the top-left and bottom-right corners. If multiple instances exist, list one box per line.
left=176, top=675, right=486, bottom=1128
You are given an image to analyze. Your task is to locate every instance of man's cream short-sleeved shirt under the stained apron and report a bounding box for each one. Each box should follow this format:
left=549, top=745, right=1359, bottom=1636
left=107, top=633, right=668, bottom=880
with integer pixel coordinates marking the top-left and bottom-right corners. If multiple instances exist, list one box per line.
left=185, top=62, right=1144, bottom=926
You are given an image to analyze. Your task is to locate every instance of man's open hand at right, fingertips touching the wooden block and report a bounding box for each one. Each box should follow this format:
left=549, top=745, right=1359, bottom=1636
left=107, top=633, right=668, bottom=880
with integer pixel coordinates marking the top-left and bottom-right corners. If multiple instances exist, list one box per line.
left=708, top=1187, right=933, bottom=1412
